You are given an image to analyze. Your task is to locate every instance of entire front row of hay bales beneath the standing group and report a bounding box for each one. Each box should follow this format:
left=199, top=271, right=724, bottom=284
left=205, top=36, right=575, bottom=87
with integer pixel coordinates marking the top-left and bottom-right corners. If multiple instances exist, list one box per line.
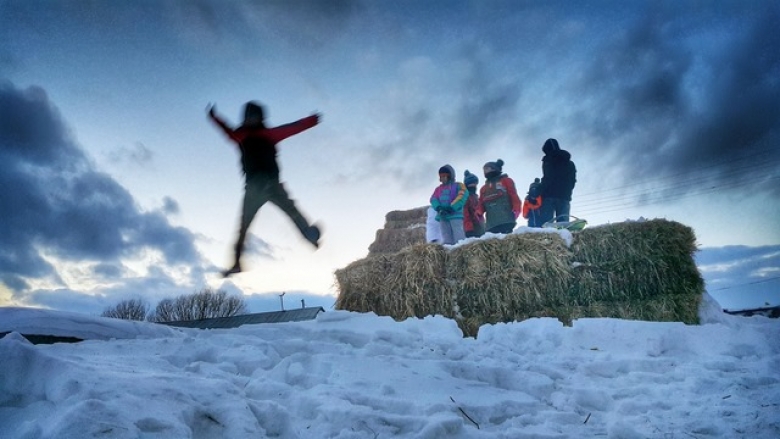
left=336, top=220, right=704, bottom=336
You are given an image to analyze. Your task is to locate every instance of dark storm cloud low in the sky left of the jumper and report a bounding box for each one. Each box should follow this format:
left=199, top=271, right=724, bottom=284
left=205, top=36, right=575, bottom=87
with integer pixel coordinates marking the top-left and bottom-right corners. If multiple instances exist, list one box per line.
left=0, top=82, right=200, bottom=292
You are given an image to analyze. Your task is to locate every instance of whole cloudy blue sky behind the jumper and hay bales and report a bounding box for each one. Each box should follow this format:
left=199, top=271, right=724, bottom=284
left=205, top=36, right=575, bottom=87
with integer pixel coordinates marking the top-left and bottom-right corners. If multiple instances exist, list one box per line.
left=0, top=0, right=780, bottom=314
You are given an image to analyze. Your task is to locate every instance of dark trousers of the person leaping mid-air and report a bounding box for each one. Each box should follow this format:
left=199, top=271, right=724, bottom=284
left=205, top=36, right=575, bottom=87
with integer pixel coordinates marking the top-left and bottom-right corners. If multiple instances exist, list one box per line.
left=235, top=174, right=309, bottom=264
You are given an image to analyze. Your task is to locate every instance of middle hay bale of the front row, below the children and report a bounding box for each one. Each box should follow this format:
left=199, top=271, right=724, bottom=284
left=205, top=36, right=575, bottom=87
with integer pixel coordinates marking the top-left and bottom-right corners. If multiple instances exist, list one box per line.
left=447, top=233, right=571, bottom=322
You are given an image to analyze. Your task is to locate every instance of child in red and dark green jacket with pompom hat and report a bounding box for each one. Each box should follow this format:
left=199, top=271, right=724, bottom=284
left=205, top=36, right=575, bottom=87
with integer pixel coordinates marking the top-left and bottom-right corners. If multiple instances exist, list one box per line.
left=477, top=159, right=523, bottom=233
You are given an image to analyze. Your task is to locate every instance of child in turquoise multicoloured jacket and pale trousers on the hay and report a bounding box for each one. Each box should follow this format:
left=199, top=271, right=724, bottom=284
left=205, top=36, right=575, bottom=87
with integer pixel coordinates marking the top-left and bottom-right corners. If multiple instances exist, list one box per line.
left=431, top=165, right=469, bottom=244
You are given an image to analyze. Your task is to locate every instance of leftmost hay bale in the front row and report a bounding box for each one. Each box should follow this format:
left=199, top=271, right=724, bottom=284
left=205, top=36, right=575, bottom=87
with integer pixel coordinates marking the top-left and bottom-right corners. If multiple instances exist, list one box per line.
left=335, top=244, right=453, bottom=320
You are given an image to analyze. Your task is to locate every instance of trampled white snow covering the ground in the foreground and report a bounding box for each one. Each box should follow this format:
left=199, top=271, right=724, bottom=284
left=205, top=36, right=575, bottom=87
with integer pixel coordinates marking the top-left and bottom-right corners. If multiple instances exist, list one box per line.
left=0, top=297, right=780, bottom=439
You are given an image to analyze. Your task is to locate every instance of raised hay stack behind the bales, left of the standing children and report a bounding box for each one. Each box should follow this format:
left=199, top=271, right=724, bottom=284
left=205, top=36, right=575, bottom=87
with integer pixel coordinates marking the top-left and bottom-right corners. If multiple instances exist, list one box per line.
left=368, top=206, right=428, bottom=255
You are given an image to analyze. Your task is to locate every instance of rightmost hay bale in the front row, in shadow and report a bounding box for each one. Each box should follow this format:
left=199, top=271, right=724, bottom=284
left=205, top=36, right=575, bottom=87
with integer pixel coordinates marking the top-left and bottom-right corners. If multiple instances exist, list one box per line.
left=570, top=219, right=704, bottom=324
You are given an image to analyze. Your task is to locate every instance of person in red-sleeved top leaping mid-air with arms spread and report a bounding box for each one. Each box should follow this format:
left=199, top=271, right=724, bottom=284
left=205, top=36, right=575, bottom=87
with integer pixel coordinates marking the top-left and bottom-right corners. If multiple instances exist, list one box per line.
left=208, top=101, right=320, bottom=277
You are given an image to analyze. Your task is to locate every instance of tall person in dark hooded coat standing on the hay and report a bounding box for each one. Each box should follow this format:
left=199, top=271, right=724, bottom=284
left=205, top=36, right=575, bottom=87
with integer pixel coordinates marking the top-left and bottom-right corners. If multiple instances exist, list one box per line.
left=541, top=139, right=577, bottom=224
